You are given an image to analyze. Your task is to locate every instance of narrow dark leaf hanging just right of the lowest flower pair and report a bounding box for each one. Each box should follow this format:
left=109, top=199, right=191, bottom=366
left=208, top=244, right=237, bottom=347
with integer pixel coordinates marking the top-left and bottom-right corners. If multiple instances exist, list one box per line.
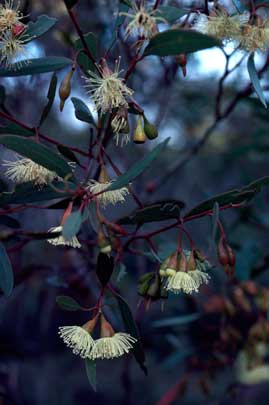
left=114, top=293, right=148, bottom=375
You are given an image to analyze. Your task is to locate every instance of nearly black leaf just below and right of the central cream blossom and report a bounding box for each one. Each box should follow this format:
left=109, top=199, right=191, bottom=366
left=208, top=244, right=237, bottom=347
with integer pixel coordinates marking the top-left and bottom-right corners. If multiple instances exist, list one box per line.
left=118, top=200, right=185, bottom=225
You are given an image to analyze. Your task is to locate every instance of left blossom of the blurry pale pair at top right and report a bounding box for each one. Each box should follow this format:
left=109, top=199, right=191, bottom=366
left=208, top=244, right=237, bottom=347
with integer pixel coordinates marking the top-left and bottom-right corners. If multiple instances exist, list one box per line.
left=193, top=10, right=249, bottom=40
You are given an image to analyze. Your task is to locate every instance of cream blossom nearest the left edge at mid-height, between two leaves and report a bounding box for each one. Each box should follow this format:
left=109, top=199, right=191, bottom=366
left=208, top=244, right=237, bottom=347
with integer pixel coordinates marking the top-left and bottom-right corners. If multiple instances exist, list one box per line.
left=3, top=157, right=58, bottom=186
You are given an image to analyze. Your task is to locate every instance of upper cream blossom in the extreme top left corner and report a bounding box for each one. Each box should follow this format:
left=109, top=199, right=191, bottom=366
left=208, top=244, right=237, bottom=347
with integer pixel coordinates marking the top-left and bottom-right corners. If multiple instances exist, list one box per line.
left=0, top=0, right=23, bottom=33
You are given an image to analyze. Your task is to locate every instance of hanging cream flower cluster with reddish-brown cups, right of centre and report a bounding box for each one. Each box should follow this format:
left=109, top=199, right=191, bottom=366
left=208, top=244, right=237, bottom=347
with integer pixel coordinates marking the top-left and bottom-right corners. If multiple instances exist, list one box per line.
left=159, top=250, right=210, bottom=294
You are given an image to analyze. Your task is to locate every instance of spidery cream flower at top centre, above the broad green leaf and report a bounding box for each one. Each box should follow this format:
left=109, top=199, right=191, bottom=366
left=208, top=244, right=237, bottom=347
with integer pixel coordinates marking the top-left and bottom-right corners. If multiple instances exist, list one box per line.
left=120, top=2, right=167, bottom=39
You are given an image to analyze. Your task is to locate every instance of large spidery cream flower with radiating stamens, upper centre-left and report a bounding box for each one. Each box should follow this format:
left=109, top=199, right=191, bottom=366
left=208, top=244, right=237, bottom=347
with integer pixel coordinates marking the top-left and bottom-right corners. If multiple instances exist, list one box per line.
left=85, top=60, right=133, bottom=113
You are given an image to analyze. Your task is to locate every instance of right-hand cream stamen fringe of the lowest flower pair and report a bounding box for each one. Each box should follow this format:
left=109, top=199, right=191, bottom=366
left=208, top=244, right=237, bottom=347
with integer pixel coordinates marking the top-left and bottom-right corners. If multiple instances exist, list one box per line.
left=89, top=332, right=136, bottom=360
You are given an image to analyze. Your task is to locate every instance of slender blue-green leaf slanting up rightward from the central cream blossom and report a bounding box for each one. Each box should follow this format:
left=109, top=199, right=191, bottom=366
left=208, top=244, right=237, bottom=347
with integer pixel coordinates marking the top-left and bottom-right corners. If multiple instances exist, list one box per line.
left=107, top=138, right=170, bottom=190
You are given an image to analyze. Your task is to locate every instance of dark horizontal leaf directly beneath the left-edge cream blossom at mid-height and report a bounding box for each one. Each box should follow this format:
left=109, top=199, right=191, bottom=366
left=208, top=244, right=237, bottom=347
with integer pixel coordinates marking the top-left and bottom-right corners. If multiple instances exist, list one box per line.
left=0, top=182, right=76, bottom=207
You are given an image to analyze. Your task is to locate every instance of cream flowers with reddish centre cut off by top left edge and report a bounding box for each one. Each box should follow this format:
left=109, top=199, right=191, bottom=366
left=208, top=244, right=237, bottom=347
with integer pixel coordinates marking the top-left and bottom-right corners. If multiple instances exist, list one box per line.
left=0, top=0, right=26, bottom=68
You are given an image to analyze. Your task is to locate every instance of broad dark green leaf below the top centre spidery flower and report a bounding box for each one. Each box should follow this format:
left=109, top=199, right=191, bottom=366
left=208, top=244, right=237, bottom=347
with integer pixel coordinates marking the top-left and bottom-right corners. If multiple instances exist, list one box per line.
left=143, top=30, right=220, bottom=56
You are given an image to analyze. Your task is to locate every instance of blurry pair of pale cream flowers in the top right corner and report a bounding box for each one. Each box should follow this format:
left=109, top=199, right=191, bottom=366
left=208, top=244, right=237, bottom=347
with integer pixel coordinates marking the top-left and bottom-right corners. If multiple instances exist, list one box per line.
left=193, top=9, right=269, bottom=52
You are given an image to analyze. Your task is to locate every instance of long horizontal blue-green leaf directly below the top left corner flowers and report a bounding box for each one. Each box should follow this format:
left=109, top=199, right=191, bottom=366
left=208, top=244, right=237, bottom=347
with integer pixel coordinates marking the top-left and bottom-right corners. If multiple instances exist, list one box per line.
left=0, top=56, right=73, bottom=77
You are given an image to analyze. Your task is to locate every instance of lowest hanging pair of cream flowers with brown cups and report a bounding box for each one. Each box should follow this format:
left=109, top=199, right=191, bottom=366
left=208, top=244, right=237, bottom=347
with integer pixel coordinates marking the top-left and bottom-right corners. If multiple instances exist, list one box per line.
left=59, top=315, right=136, bottom=360
